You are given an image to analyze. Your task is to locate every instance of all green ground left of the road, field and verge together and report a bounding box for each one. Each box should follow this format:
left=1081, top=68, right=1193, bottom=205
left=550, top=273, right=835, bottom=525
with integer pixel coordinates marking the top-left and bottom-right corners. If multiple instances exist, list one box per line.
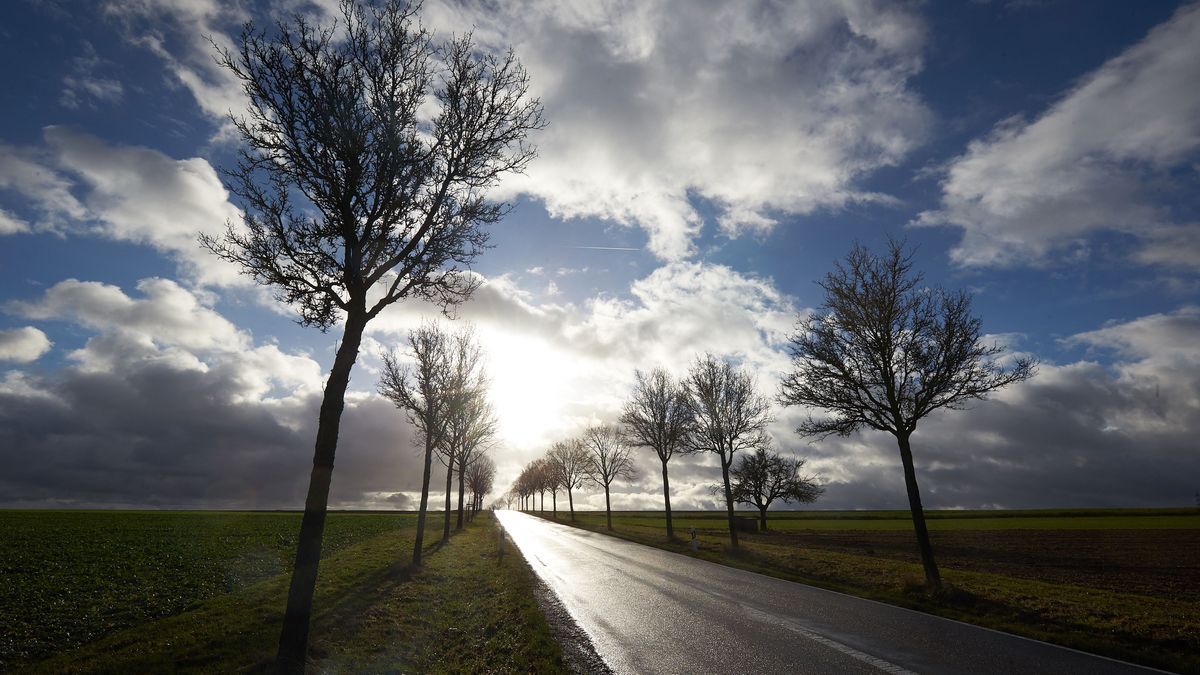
left=0, top=510, right=560, bottom=673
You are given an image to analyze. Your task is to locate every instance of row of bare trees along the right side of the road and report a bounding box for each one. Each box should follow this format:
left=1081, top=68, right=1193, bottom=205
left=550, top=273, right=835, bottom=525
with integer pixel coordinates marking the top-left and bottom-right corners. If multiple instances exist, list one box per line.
left=504, top=240, right=1037, bottom=589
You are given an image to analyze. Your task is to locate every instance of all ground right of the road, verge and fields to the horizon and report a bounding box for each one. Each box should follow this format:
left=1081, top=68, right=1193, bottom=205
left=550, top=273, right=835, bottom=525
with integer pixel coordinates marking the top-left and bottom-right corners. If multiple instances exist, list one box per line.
left=535, top=508, right=1200, bottom=673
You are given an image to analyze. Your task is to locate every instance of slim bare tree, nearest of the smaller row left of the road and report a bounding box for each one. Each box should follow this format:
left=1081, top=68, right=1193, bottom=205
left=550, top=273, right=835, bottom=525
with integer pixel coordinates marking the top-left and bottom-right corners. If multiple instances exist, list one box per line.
left=379, top=323, right=458, bottom=566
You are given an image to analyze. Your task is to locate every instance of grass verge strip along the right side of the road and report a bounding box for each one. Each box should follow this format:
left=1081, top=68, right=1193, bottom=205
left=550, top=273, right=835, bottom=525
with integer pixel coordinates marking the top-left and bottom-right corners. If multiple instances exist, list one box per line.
left=540, top=512, right=1200, bottom=673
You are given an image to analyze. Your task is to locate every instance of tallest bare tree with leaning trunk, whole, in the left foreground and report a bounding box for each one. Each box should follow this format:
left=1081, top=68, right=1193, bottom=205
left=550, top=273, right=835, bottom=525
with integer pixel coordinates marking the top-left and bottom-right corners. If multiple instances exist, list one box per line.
left=200, top=0, right=542, bottom=671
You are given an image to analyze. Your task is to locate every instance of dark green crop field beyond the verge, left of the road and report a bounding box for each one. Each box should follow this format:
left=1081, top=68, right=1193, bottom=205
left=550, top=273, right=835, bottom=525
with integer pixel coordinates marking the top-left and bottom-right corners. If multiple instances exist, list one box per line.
left=0, top=510, right=413, bottom=670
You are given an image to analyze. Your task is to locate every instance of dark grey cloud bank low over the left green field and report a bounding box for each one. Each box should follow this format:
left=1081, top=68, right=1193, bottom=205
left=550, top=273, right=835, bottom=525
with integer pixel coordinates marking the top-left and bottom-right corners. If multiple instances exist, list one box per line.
left=0, top=362, right=420, bottom=508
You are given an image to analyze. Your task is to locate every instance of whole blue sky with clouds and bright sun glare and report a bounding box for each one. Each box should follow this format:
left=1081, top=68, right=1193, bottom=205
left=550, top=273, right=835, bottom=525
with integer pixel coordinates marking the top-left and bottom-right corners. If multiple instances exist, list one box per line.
left=0, top=0, right=1200, bottom=509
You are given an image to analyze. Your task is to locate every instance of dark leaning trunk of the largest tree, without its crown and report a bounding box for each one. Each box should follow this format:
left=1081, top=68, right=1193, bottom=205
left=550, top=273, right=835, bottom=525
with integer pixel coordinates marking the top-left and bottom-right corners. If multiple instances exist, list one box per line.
left=276, top=311, right=367, bottom=674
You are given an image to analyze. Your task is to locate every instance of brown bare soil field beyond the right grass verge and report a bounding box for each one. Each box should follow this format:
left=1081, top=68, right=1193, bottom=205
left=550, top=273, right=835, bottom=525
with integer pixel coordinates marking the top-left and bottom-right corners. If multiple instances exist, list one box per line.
left=744, top=530, right=1200, bottom=602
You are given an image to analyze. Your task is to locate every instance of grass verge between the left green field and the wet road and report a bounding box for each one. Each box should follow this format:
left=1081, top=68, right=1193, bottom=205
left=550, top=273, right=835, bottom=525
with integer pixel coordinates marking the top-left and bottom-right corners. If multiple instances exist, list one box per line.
left=26, top=513, right=564, bottom=673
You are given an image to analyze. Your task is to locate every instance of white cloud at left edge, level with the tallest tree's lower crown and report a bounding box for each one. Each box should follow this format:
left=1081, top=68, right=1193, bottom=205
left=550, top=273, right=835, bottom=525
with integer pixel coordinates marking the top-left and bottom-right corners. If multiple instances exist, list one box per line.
left=0, top=126, right=247, bottom=286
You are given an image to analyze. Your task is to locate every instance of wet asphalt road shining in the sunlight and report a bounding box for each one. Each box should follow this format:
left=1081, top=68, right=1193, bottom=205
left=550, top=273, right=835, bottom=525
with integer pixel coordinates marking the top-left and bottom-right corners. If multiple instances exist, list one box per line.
left=498, top=510, right=1153, bottom=674
